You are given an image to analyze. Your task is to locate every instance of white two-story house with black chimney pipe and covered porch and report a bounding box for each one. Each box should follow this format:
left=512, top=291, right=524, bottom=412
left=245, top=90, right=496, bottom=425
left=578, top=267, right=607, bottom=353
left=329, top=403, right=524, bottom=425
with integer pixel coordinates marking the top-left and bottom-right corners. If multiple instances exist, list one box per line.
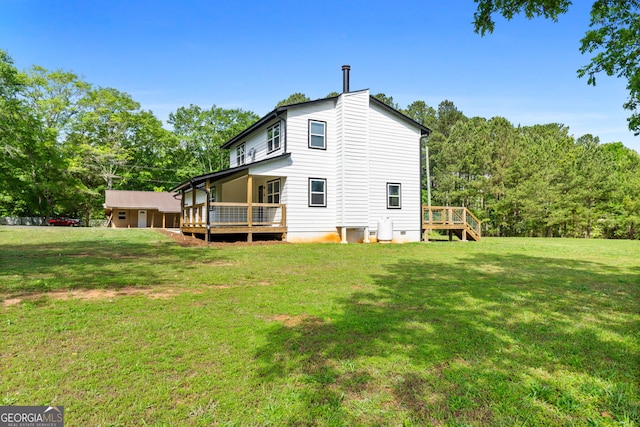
left=173, top=66, right=430, bottom=242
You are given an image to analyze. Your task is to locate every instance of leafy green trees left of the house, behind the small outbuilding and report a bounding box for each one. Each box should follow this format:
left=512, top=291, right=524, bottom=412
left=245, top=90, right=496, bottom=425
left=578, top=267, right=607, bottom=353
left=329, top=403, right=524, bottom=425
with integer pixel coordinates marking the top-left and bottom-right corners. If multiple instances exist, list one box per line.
left=0, top=50, right=258, bottom=222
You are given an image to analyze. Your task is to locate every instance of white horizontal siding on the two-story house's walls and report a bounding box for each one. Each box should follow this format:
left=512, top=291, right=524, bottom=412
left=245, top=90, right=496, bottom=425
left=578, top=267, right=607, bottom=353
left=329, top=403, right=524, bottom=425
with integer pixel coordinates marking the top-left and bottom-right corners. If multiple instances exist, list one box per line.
left=225, top=90, right=421, bottom=241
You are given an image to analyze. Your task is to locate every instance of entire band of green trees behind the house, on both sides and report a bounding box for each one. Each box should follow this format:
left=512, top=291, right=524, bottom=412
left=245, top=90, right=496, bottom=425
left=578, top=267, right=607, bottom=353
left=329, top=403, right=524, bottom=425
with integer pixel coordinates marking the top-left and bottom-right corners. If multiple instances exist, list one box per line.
left=0, top=50, right=640, bottom=239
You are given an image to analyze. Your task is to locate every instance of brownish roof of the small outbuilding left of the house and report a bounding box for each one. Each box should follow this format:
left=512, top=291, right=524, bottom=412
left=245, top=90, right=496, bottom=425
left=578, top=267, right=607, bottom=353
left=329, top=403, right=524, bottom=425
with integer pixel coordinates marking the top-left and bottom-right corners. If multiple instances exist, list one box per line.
left=104, top=190, right=180, bottom=213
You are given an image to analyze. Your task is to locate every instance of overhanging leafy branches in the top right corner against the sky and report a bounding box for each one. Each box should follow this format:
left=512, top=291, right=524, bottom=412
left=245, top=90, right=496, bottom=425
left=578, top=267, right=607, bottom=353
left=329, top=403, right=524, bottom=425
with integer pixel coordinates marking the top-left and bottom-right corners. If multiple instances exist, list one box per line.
left=474, top=0, right=640, bottom=135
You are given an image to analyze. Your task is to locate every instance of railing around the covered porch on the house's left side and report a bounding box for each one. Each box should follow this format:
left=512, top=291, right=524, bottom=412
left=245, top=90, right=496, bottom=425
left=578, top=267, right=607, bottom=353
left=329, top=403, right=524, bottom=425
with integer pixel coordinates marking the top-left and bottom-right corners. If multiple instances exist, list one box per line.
left=182, top=202, right=286, bottom=228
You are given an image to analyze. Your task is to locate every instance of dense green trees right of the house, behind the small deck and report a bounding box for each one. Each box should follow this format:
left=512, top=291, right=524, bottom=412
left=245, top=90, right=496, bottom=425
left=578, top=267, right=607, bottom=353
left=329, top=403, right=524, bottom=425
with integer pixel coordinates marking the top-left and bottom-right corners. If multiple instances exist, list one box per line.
left=400, top=95, right=640, bottom=239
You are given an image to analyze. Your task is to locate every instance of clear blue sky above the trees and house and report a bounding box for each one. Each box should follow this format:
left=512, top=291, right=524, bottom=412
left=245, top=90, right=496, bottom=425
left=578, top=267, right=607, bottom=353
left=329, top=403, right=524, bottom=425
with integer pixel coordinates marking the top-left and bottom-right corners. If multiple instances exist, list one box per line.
left=0, top=0, right=640, bottom=152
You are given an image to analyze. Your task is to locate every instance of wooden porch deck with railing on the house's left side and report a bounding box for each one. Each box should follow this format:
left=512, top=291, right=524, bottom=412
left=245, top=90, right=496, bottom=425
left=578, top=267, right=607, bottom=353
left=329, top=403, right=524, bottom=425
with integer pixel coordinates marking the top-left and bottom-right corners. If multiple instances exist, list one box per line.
left=180, top=202, right=287, bottom=242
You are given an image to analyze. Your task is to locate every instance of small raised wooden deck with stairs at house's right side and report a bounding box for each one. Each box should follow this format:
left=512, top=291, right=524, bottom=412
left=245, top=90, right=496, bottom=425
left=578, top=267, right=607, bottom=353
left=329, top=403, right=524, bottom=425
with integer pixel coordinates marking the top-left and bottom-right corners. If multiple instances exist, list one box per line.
left=422, top=205, right=481, bottom=242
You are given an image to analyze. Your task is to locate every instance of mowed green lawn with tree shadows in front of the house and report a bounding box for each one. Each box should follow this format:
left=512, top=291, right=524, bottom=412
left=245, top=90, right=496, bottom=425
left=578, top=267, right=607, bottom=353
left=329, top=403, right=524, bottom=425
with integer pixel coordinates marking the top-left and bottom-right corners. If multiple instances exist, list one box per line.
left=0, top=227, right=640, bottom=426
